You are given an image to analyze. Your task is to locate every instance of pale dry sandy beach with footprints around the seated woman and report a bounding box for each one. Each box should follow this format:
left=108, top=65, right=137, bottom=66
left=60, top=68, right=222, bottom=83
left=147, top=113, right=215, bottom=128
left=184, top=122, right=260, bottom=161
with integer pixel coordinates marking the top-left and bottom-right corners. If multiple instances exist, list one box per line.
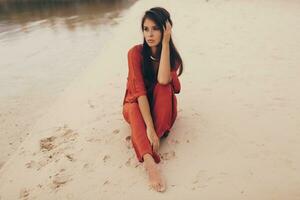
left=0, top=0, right=300, bottom=200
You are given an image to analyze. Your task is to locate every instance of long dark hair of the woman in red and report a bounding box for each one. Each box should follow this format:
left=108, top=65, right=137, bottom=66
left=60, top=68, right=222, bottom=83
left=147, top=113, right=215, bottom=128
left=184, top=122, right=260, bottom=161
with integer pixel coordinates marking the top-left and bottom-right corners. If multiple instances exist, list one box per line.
left=141, top=7, right=183, bottom=83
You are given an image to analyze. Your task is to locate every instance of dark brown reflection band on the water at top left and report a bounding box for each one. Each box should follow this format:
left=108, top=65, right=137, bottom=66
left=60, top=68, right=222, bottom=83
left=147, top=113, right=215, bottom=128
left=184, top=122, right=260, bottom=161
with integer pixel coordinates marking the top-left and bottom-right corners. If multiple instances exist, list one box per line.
left=0, top=0, right=135, bottom=40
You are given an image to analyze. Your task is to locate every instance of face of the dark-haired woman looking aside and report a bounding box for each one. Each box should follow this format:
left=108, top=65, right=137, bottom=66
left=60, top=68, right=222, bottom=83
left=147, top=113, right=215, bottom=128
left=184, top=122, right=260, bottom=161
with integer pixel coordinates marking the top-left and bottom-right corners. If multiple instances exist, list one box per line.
left=143, top=18, right=161, bottom=47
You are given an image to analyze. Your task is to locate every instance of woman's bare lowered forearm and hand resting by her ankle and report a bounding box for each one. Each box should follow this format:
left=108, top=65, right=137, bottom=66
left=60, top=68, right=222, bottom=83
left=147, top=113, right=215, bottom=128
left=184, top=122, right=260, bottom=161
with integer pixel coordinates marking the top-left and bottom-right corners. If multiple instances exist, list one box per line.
left=138, top=95, right=159, bottom=152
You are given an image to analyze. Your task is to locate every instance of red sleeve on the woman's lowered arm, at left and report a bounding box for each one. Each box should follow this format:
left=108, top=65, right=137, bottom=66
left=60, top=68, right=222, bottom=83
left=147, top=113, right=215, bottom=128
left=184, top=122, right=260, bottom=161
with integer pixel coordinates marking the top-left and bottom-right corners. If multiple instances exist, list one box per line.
left=128, top=48, right=147, bottom=99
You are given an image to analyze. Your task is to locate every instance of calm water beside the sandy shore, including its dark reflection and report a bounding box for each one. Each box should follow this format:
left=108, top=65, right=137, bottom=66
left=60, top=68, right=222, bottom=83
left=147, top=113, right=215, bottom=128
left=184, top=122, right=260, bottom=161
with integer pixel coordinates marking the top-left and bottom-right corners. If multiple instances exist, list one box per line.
left=0, top=1, right=134, bottom=168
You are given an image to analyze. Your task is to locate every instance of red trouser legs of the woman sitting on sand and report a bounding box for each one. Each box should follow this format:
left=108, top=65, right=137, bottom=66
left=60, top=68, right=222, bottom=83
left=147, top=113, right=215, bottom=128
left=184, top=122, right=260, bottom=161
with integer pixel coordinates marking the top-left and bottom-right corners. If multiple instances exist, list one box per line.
left=123, top=84, right=177, bottom=163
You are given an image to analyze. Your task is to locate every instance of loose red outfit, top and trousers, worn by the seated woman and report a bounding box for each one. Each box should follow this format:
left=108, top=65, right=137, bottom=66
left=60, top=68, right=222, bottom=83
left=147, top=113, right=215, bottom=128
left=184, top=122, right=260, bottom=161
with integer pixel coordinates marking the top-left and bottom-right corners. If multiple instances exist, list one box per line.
left=123, top=44, right=180, bottom=163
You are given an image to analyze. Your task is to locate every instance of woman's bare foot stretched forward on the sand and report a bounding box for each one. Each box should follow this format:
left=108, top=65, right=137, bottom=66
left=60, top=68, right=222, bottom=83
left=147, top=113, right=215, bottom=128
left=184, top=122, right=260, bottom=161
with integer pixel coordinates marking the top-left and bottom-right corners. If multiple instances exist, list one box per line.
left=143, top=154, right=166, bottom=192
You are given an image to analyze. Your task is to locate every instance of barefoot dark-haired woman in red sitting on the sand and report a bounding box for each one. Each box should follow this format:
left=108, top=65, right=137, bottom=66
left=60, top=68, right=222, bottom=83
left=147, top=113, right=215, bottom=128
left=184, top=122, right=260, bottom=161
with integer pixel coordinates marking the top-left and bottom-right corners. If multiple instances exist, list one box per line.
left=123, top=7, right=183, bottom=192
